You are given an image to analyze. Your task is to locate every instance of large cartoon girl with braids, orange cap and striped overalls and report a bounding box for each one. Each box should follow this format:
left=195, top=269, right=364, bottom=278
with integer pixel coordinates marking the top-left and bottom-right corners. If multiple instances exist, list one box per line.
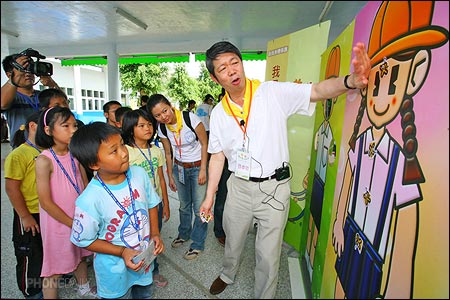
left=332, top=1, right=448, bottom=299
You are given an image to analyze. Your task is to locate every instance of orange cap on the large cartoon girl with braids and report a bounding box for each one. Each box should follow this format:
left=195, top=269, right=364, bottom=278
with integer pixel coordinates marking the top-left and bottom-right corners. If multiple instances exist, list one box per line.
left=367, top=1, right=448, bottom=66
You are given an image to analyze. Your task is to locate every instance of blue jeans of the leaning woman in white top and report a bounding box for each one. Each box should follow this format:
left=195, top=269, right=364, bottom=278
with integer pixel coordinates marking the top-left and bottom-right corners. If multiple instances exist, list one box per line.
left=172, top=164, right=208, bottom=251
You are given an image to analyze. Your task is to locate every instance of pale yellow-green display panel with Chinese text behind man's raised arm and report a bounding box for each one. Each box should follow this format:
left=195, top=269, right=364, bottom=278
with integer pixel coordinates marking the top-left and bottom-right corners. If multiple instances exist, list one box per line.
left=266, top=21, right=330, bottom=251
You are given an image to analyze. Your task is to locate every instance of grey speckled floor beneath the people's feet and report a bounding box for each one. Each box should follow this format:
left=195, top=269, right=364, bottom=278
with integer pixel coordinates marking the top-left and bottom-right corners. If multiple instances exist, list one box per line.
left=1, top=144, right=303, bottom=299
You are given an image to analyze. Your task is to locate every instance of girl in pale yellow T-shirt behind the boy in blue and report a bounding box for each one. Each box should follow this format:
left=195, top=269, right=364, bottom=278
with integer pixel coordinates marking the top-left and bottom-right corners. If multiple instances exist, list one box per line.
left=122, top=109, right=170, bottom=287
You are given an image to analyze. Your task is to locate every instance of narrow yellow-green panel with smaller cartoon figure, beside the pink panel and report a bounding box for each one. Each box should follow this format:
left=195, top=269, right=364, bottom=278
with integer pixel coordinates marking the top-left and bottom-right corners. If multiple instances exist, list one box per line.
left=302, top=22, right=354, bottom=298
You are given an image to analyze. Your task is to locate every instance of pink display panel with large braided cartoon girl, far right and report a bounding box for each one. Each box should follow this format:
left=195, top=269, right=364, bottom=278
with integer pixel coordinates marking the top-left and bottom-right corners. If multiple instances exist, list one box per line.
left=313, top=1, right=449, bottom=299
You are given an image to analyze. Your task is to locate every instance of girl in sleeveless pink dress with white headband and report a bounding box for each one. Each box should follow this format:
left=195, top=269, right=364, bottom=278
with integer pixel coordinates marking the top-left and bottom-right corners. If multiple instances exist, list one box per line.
left=36, top=106, right=96, bottom=299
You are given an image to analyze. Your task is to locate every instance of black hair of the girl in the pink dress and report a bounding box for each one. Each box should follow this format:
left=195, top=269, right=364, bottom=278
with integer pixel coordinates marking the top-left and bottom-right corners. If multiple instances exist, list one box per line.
left=36, top=106, right=78, bottom=149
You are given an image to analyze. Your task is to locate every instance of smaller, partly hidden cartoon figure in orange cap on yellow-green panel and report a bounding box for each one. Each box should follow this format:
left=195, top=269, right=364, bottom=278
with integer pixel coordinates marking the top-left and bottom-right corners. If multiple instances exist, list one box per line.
left=306, top=45, right=341, bottom=280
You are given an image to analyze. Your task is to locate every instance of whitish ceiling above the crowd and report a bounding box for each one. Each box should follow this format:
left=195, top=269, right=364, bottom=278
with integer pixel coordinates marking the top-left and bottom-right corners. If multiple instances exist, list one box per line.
left=1, top=1, right=367, bottom=57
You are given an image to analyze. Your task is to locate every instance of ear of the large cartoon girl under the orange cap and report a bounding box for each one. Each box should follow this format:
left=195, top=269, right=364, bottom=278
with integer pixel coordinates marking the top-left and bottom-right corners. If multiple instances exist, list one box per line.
left=406, top=50, right=430, bottom=96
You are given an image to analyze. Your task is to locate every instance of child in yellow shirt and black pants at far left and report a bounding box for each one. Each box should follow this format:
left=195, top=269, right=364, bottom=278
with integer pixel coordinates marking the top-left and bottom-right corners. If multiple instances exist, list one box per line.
left=5, top=112, right=43, bottom=299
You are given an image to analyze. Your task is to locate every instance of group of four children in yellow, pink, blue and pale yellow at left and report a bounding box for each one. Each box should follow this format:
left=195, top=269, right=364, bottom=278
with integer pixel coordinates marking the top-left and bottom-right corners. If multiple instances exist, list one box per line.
left=5, top=90, right=170, bottom=299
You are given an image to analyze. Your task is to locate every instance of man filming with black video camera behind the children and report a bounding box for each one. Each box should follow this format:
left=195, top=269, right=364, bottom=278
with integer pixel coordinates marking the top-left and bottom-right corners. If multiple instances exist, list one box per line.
left=1, top=49, right=59, bottom=146
